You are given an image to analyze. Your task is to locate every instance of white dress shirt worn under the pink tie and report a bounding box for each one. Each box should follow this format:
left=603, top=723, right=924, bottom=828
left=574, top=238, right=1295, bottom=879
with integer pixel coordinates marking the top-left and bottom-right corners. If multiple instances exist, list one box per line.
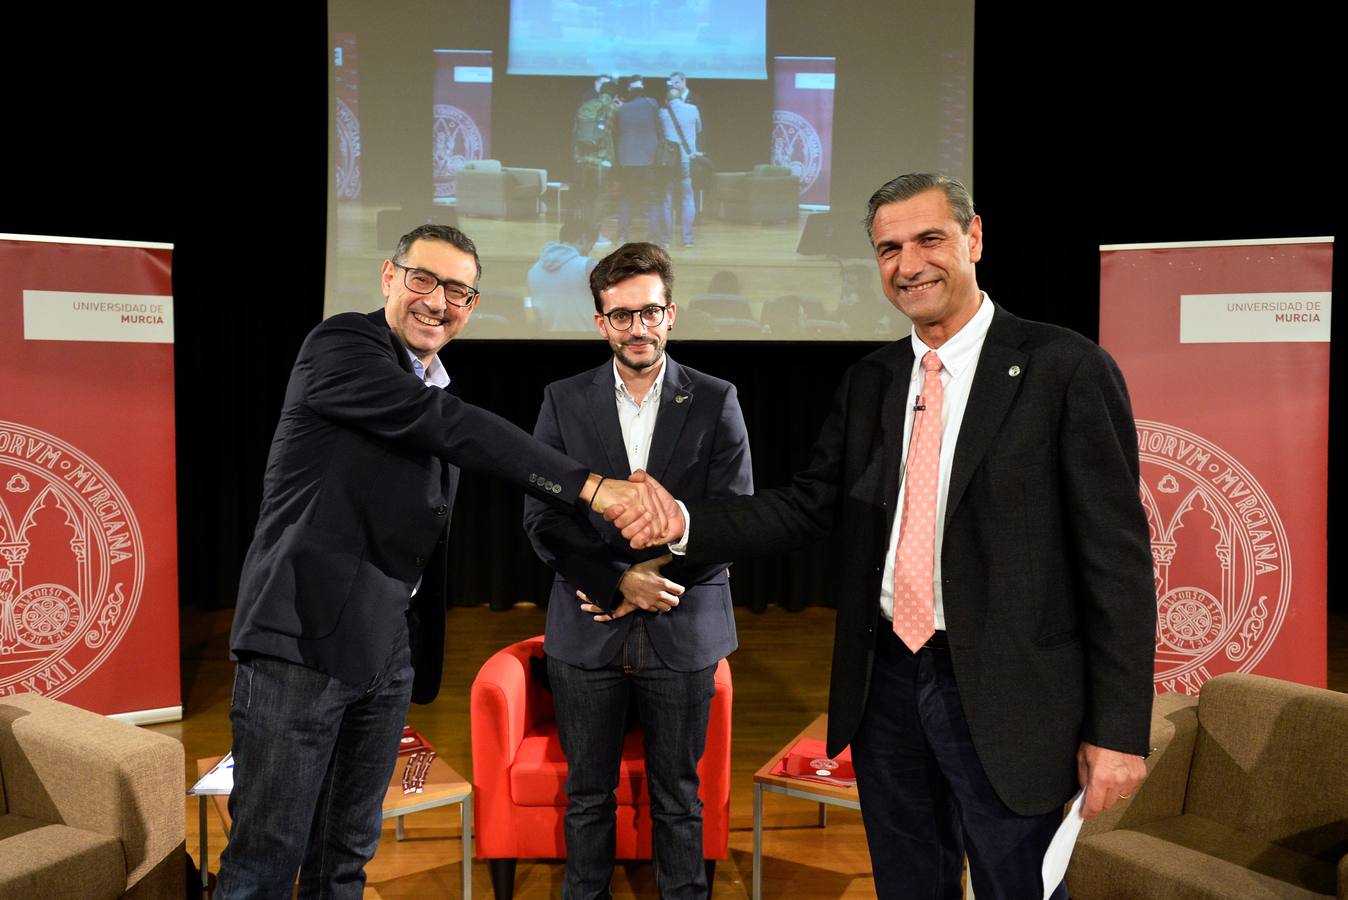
left=880, top=294, right=992, bottom=631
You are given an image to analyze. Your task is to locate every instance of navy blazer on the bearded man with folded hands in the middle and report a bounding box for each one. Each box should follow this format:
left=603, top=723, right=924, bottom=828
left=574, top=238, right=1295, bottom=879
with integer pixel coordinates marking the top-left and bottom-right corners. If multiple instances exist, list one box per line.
left=524, top=356, right=754, bottom=672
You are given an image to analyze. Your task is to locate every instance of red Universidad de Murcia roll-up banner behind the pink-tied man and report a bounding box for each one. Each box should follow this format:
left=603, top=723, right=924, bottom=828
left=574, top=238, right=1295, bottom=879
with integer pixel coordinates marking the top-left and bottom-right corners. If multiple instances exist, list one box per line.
left=1100, top=238, right=1333, bottom=694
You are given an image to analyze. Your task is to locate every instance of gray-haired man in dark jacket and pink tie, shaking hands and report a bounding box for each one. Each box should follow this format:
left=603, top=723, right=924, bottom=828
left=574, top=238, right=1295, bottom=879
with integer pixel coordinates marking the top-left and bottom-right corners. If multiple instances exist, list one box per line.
left=613, top=175, right=1155, bottom=900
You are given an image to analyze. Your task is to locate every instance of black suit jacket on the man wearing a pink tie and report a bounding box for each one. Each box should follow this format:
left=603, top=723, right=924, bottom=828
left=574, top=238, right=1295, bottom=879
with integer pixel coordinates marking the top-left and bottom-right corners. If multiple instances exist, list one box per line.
left=687, top=307, right=1157, bottom=815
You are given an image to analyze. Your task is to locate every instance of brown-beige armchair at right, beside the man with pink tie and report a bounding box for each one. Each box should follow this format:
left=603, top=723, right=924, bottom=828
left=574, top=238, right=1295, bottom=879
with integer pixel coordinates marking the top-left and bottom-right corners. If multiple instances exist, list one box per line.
left=1068, top=674, right=1348, bottom=900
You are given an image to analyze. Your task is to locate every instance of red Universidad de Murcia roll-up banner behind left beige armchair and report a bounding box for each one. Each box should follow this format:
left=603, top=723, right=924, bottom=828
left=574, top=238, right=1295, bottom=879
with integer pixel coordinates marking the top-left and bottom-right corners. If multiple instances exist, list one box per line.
left=0, top=234, right=182, bottom=722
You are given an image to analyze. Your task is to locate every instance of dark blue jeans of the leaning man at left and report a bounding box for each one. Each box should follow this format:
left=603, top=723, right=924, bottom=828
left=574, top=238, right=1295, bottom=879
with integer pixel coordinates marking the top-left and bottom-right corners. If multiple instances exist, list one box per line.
left=214, top=620, right=412, bottom=900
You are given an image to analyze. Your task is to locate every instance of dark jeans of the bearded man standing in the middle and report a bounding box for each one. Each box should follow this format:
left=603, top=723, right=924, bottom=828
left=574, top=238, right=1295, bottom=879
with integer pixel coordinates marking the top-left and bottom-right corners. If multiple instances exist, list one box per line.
left=547, top=613, right=716, bottom=900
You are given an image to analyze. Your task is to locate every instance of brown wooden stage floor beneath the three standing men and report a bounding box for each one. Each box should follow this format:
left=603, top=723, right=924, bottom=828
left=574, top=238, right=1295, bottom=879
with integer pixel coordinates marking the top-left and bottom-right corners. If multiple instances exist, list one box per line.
left=151, top=605, right=1348, bottom=900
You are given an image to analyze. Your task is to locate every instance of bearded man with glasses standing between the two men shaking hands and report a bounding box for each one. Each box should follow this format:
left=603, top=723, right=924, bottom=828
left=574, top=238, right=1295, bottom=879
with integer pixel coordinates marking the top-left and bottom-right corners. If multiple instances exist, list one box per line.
left=524, top=244, right=754, bottom=900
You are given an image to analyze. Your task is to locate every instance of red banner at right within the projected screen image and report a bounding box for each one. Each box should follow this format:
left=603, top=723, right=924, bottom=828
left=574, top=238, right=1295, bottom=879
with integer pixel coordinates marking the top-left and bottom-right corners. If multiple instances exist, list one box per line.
left=772, top=57, right=837, bottom=209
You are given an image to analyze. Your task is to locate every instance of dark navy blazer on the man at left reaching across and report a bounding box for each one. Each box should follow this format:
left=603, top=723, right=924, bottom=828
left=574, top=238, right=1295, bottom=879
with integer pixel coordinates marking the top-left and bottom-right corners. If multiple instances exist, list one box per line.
left=229, top=309, right=589, bottom=703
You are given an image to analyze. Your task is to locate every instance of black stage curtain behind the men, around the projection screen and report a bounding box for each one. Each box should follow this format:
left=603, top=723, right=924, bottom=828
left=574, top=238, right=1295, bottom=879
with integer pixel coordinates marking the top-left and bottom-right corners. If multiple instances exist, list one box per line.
left=0, top=3, right=1348, bottom=609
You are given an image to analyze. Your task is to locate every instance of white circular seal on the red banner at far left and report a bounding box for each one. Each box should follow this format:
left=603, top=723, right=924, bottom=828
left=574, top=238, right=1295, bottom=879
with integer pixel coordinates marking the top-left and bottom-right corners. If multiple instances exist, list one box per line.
left=0, top=420, right=146, bottom=697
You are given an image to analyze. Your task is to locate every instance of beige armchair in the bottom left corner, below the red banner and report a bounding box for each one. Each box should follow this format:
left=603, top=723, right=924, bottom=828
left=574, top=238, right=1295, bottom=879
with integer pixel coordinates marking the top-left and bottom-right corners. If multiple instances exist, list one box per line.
left=0, top=694, right=186, bottom=900
